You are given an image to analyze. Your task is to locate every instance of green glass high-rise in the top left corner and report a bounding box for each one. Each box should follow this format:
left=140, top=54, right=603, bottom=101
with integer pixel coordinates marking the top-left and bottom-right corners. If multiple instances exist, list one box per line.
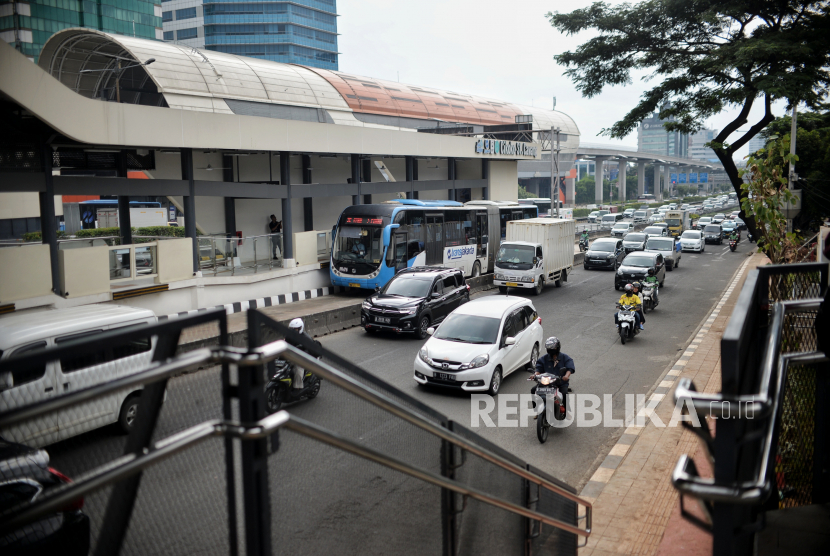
left=0, top=0, right=162, bottom=62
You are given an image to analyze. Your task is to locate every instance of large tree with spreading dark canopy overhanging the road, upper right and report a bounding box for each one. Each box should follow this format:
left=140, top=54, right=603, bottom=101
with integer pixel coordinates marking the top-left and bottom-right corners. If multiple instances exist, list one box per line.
left=547, top=0, right=830, bottom=239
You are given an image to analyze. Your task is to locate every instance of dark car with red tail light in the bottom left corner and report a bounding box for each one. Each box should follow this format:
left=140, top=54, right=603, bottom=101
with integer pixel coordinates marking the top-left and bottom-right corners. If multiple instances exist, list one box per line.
left=0, top=439, right=89, bottom=556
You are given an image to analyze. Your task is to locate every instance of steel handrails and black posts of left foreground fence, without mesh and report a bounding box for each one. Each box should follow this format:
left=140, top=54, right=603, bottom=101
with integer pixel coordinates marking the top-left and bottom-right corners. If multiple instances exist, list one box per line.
left=0, top=311, right=592, bottom=554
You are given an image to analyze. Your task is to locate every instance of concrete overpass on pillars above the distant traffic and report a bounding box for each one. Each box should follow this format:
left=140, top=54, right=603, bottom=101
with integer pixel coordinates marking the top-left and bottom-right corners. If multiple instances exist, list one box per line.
left=518, top=142, right=723, bottom=205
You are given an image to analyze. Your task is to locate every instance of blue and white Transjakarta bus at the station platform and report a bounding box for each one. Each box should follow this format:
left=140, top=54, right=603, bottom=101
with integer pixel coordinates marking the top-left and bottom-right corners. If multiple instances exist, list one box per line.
left=329, top=199, right=538, bottom=289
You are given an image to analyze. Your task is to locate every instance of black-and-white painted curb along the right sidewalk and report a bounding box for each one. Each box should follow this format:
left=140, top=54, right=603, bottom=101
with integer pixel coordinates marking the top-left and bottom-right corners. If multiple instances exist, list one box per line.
left=580, top=252, right=755, bottom=502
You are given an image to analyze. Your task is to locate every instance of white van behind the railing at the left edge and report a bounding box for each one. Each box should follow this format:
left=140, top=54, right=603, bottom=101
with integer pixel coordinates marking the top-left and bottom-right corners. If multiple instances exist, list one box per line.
left=0, top=305, right=156, bottom=448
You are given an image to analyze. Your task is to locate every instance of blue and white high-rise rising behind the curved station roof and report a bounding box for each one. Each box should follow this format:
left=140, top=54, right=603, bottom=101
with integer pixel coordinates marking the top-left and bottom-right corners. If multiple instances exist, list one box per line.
left=162, top=0, right=338, bottom=70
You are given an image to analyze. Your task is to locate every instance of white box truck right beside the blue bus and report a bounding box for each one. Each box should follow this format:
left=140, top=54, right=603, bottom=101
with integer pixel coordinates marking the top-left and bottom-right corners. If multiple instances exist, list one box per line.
left=493, top=218, right=576, bottom=295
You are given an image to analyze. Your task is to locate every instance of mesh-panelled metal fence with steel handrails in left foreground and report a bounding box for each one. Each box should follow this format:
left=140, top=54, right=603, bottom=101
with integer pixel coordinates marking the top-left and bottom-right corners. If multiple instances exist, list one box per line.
left=0, top=310, right=591, bottom=555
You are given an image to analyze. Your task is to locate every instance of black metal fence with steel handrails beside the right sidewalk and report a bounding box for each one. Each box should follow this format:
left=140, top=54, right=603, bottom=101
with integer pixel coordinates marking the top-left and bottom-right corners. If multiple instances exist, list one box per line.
left=672, top=263, right=830, bottom=556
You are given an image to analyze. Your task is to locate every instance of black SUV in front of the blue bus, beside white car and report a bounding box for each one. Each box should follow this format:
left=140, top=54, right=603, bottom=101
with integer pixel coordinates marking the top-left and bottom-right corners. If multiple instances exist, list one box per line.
left=360, top=266, right=470, bottom=339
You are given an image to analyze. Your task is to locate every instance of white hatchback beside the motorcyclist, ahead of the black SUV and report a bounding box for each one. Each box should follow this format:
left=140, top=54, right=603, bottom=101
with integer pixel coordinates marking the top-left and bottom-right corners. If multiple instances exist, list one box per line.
left=415, top=295, right=544, bottom=396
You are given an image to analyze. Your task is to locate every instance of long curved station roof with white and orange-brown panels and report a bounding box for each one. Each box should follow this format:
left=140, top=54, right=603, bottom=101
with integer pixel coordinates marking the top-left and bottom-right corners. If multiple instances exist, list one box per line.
left=38, top=28, right=579, bottom=142
